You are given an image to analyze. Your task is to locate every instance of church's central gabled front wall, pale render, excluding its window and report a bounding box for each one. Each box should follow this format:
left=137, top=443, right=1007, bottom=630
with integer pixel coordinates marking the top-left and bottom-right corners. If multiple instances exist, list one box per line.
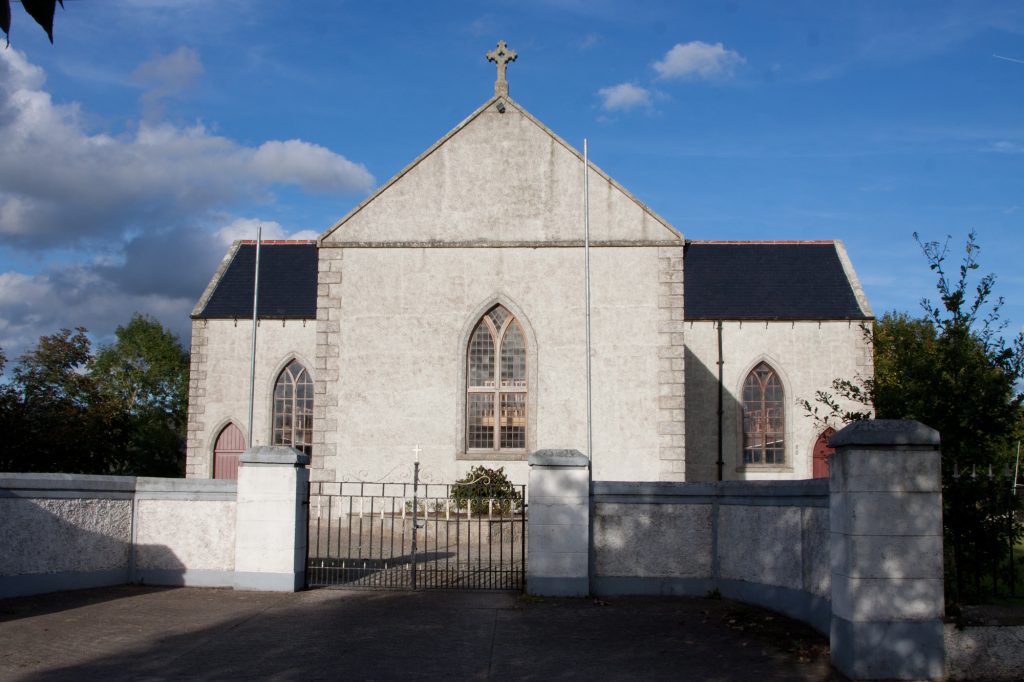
left=311, top=98, right=686, bottom=483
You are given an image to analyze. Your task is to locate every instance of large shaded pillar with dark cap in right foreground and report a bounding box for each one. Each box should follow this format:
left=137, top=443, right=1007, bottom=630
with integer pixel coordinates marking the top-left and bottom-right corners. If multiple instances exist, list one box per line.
left=828, top=420, right=945, bottom=680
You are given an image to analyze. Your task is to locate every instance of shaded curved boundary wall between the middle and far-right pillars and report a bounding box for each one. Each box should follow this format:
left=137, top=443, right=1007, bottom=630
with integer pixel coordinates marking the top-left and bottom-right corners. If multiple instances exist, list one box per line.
left=593, top=480, right=831, bottom=634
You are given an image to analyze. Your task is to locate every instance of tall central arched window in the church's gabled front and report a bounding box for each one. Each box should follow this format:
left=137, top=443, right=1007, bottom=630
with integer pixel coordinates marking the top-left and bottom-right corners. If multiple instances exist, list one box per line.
left=466, top=305, right=526, bottom=453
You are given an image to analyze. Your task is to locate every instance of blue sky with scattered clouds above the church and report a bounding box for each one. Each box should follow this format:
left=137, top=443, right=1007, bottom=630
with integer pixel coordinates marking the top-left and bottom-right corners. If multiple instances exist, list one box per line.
left=0, top=0, right=1024, bottom=359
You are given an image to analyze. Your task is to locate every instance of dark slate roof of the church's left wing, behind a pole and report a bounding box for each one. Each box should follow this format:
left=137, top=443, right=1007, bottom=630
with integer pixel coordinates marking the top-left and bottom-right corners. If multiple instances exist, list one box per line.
left=194, top=241, right=317, bottom=319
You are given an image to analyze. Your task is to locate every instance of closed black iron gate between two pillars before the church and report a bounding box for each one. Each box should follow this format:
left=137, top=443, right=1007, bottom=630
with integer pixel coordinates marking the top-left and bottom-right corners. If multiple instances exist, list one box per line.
left=306, top=481, right=526, bottom=590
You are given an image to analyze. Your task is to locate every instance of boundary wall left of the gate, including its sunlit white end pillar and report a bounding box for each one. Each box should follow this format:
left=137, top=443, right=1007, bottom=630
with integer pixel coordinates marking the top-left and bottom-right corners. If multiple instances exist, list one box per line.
left=0, top=446, right=308, bottom=598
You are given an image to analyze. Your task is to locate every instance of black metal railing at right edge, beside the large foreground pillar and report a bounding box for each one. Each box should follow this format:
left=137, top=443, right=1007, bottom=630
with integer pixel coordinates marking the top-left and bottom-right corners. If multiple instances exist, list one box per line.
left=942, top=468, right=1024, bottom=604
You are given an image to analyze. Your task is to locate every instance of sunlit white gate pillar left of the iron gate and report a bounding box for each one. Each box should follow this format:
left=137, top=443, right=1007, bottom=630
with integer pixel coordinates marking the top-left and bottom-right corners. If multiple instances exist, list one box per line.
left=234, top=445, right=309, bottom=592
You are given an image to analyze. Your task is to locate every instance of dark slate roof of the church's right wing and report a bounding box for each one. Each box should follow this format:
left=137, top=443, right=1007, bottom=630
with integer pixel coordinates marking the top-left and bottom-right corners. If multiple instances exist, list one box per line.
left=683, top=242, right=870, bottom=319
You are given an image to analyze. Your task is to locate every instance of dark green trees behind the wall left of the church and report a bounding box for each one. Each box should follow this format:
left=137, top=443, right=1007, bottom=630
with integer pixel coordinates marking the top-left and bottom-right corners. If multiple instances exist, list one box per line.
left=0, top=315, right=188, bottom=476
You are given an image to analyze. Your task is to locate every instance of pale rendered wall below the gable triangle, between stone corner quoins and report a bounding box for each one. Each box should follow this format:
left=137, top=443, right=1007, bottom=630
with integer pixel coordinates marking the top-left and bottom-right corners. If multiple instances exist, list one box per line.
left=321, top=247, right=681, bottom=483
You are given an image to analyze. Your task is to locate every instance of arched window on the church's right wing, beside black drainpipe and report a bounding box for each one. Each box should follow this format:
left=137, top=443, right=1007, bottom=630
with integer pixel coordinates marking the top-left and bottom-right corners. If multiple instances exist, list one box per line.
left=743, top=363, right=785, bottom=465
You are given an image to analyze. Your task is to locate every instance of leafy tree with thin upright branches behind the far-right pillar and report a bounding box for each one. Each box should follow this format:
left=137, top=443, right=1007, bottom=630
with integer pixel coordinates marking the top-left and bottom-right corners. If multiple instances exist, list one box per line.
left=803, top=228, right=1024, bottom=466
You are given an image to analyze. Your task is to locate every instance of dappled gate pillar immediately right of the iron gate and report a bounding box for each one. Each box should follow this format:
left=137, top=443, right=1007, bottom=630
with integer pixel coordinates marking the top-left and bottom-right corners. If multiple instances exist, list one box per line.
left=526, top=450, right=590, bottom=597
